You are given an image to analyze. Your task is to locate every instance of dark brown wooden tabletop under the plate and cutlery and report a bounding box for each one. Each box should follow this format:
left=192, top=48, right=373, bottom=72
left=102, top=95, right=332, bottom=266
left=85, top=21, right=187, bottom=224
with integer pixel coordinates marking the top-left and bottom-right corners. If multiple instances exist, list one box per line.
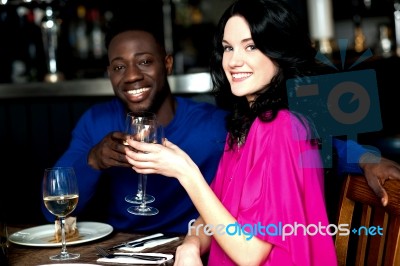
left=8, top=225, right=184, bottom=266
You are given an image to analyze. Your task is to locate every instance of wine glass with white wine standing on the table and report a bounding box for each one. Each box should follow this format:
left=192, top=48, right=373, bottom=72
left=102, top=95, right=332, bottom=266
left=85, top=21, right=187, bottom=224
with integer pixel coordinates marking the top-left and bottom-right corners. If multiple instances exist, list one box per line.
left=43, top=167, right=80, bottom=260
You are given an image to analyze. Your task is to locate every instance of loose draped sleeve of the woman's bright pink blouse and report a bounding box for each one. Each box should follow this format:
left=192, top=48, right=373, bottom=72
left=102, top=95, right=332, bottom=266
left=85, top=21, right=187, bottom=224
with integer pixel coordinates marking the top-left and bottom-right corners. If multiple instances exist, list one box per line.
left=237, top=111, right=332, bottom=262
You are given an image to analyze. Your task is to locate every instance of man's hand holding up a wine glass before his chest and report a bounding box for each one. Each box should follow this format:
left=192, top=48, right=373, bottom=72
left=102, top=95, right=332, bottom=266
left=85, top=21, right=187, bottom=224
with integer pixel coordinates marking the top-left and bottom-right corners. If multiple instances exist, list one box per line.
left=88, top=132, right=132, bottom=170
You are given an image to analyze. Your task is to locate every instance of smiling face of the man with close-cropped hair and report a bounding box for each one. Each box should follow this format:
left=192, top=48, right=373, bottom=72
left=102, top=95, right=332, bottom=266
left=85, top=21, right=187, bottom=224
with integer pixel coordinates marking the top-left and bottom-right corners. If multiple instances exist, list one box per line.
left=107, top=31, right=172, bottom=112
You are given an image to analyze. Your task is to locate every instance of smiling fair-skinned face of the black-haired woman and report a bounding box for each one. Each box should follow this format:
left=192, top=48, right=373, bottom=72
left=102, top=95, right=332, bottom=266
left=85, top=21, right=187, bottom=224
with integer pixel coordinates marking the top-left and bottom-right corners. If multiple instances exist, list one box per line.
left=222, top=16, right=278, bottom=102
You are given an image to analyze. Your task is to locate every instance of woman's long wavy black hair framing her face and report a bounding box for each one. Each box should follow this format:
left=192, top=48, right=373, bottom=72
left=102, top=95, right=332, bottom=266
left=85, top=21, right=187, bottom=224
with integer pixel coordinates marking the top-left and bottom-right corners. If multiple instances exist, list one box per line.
left=210, top=0, right=316, bottom=148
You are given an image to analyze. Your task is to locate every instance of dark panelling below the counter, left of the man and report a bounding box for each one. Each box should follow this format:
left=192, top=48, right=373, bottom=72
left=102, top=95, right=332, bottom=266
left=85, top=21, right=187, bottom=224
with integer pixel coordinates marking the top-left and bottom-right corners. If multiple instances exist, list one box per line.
left=0, top=96, right=110, bottom=223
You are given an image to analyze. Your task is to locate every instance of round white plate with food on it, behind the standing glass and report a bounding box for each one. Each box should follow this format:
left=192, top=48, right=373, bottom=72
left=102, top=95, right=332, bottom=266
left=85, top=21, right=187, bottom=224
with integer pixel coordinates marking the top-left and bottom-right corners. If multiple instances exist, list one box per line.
left=8, top=222, right=113, bottom=247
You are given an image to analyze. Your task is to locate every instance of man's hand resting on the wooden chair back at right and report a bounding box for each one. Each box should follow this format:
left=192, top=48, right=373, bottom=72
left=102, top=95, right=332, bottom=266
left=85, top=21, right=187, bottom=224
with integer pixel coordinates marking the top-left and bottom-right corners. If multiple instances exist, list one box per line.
left=360, top=153, right=400, bottom=206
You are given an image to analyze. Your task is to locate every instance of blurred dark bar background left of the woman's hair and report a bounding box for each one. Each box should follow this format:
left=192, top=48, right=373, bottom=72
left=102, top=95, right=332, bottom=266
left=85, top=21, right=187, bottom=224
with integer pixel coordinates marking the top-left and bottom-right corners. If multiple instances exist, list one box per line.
left=0, top=0, right=234, bottom=83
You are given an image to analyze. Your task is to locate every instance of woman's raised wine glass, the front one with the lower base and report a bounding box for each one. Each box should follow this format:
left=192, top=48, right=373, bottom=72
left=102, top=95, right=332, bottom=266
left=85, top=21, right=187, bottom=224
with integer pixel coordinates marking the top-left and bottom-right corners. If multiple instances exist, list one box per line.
left=128, top=112, right=159, bottom=216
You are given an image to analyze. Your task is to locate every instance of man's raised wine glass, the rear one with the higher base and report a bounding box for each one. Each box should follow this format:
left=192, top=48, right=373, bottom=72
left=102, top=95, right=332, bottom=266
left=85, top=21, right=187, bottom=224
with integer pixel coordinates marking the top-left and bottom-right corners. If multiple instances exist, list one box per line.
left=125, top=111, right=156, bottom=204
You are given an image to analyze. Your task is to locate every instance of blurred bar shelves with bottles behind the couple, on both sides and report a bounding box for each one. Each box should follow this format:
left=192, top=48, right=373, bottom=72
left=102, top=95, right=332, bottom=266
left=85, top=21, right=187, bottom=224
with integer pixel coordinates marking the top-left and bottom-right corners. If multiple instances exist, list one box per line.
left=0, top=0, right=397, bottom=83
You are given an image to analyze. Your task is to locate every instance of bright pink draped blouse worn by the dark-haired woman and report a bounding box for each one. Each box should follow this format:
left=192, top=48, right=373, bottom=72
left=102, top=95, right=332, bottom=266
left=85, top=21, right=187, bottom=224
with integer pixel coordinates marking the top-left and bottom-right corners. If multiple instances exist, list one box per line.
left=208, top=111, right=337, bottom=266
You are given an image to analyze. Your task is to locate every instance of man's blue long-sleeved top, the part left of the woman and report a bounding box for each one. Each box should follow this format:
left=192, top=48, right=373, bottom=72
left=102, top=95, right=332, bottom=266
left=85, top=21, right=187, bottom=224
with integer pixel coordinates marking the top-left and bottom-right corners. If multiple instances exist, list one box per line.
left=43, top=97, right=227, bottom=233
